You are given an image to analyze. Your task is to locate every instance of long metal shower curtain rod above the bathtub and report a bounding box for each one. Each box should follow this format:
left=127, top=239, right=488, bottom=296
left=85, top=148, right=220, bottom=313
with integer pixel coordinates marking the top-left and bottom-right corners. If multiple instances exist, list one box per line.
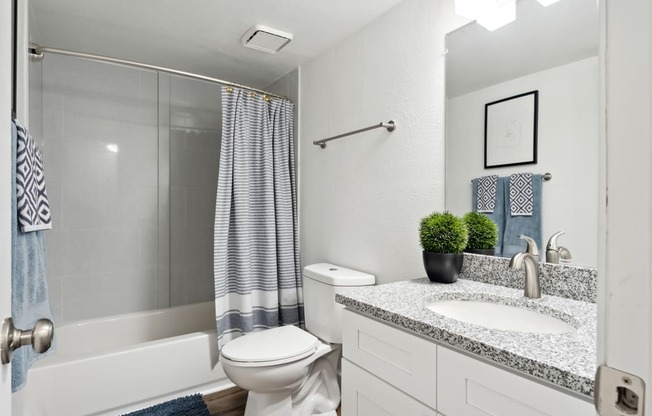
left=27, top=43, right=289, bottom=101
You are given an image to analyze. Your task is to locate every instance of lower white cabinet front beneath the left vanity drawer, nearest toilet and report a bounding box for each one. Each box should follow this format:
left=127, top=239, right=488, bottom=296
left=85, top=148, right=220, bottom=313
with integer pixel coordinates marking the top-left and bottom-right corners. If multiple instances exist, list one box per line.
left=342, top=358, right=437, bottom=416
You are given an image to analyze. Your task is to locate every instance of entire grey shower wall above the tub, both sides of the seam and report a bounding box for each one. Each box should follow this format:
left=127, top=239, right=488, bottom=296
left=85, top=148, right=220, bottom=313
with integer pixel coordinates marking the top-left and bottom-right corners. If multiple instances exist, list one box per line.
left=38, top=55, right=221, bottom=325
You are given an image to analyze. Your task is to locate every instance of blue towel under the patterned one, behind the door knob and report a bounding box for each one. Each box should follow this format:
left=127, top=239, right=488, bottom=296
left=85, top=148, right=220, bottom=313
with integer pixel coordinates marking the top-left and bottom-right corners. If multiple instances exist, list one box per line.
left=11, top=118, right=55, bottom=391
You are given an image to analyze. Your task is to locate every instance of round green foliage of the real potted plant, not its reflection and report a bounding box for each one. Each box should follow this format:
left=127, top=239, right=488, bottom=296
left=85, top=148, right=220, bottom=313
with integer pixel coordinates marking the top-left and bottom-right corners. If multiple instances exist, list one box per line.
left=419, top=211, right=468, bottom=254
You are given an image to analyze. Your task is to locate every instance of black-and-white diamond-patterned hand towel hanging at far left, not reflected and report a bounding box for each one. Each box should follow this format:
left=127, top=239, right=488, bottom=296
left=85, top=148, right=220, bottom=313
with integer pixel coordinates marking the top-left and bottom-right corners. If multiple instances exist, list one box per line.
left=15, top=121, right=52, bottom=232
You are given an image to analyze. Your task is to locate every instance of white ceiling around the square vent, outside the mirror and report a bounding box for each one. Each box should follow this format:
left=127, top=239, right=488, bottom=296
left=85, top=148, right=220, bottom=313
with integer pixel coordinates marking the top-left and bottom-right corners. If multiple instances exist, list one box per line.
left=30, top=0, right=401, bottom=88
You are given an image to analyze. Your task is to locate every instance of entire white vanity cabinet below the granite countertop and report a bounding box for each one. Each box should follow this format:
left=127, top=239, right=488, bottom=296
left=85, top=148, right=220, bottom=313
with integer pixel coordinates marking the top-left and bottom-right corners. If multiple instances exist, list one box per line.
left=342, top=309, right=595, bottom=416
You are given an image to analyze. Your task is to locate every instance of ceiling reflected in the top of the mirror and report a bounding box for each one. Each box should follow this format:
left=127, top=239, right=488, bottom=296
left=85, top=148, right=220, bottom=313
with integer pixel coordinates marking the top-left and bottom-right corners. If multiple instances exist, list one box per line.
left=446, top=0, right=598, bottom=98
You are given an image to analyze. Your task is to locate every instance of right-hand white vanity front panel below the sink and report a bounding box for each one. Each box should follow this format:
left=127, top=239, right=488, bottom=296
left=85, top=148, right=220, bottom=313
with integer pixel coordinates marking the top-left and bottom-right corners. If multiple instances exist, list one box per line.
left=437, top=347, right=595, bottom=416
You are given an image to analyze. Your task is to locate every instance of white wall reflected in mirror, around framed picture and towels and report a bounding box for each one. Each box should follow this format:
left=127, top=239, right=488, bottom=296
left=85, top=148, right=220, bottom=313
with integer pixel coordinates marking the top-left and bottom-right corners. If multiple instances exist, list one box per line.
left=446, top=57, right=599, bottom=267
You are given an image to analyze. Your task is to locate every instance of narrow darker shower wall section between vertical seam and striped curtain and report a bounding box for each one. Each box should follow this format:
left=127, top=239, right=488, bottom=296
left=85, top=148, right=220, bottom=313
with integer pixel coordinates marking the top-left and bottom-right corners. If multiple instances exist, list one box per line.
left=170, top=77, right=222, bottom=306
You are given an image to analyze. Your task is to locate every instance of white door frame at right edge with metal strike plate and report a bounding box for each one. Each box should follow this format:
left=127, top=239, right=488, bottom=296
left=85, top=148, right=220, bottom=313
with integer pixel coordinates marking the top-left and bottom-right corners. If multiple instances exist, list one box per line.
left=597, top=0, right=652, bottom=406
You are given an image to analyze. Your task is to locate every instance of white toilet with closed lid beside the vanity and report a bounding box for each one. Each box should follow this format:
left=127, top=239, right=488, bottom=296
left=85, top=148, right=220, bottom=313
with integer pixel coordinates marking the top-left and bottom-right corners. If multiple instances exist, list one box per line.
left=220, top=263, right=375, bottom=416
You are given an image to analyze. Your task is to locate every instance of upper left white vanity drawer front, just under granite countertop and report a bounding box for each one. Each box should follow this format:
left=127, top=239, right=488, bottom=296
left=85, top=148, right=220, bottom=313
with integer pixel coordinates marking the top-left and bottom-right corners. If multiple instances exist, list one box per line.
left=342, top=309, right=437, bottom=408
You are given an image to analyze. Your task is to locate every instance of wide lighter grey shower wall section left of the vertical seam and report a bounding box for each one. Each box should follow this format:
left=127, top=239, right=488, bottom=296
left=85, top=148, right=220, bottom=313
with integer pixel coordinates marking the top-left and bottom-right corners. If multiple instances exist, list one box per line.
left=43, top=56, right=159, bottom=323
